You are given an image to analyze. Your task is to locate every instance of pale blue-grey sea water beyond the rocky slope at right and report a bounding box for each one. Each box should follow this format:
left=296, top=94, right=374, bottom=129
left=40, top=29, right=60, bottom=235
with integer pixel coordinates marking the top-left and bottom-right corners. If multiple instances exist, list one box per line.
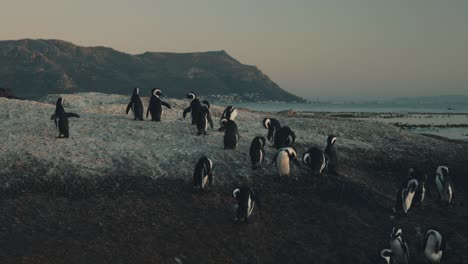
left=231, top=103, right=468, bottom=141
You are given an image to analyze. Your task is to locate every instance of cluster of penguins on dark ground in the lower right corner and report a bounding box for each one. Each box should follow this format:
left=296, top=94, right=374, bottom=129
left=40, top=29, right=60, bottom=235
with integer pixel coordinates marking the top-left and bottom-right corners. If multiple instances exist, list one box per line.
left=380, top=166, right=454, bottom=264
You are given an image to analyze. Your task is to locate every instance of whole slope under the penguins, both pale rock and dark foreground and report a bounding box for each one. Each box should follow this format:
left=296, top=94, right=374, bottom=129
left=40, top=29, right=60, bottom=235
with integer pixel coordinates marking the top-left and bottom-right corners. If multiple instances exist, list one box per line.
left=0, top=93, right=468, bottom=263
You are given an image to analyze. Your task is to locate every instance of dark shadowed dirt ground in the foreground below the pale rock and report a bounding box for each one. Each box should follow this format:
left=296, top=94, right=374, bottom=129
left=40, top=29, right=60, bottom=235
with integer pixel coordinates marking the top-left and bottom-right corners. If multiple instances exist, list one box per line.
left=0, top=142, right=468, bottom=264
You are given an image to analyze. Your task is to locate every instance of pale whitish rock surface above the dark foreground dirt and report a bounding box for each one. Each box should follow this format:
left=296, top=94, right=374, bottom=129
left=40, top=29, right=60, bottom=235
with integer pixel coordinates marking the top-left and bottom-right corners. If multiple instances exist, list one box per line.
left=0, top=93, right=464, bottom=189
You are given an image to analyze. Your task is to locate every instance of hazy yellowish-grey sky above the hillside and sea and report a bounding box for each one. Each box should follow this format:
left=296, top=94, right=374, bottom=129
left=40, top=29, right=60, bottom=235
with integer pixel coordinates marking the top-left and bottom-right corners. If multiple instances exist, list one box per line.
left=0, top=0, right=468, bottom=98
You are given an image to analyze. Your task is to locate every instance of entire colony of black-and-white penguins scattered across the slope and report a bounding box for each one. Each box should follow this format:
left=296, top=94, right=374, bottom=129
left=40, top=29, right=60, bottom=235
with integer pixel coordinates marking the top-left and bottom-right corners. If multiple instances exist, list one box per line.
left=51, top=88, right=453, bottom=264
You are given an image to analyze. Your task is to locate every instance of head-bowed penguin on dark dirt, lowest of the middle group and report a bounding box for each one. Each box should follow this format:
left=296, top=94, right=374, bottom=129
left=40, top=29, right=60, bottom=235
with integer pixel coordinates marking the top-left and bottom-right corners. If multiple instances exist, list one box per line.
left=232, top=186, right=260, bottom=223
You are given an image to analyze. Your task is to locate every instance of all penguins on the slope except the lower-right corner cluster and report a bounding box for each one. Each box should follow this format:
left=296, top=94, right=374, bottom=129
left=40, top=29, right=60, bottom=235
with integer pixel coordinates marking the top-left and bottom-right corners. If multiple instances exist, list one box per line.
left=51, top=88, right=338, bottom=222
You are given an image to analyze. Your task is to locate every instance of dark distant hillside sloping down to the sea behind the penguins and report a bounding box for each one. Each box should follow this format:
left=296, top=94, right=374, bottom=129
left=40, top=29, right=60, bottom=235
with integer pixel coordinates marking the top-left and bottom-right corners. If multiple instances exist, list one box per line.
left=0, top=39, right=303, bottom=101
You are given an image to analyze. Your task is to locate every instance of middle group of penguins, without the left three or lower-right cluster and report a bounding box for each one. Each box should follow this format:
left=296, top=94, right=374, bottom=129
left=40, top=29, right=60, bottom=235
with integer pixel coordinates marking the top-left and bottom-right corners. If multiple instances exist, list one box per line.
left=183, top=96, right=338, bottom=223
